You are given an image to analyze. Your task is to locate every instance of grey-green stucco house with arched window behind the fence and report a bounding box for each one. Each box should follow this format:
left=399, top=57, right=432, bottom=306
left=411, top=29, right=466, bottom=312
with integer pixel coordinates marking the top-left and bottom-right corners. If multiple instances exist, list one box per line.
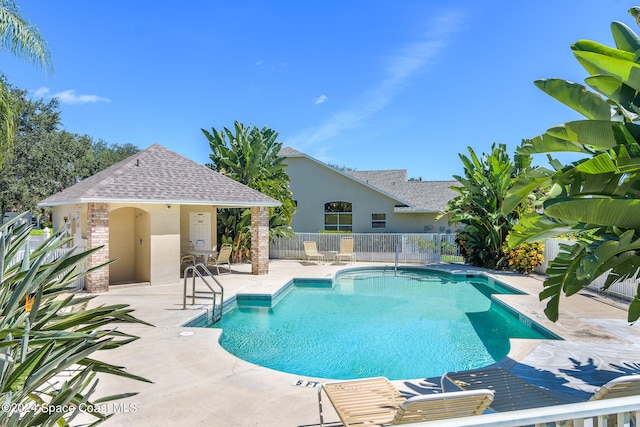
left=280, top=147, right=459, bottom=233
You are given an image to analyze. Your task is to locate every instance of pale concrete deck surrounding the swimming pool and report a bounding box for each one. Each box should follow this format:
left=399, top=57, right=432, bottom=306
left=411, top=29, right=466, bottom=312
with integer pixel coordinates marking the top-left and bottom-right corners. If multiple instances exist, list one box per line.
left=85, top=260, right=640, bottom=427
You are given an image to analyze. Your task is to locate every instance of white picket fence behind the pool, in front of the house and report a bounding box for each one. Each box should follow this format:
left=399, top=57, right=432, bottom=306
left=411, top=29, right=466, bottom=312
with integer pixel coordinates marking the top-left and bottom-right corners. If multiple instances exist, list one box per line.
left=269, top=233, right=462, bottom=263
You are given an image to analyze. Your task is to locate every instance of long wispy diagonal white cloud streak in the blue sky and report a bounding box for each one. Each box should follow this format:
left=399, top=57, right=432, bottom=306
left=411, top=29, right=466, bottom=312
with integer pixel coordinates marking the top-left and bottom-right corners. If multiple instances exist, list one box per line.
left=290, top=12, right=464, bottom=148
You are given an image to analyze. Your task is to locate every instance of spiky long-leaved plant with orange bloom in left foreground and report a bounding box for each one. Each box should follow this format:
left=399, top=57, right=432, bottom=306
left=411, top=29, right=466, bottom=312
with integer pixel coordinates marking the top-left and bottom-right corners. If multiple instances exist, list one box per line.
left=0, top=214, right=148, bottom=426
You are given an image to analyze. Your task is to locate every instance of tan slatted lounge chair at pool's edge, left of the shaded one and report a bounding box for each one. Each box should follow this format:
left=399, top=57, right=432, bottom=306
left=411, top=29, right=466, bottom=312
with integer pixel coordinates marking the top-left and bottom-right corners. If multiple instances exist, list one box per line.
left=318, top=377, right=493, bottom=427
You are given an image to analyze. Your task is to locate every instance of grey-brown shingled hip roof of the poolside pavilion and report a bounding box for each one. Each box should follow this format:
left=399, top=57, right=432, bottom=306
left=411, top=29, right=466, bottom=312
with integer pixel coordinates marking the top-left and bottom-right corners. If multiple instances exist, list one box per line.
left=38, top=144, right=280, bottom=207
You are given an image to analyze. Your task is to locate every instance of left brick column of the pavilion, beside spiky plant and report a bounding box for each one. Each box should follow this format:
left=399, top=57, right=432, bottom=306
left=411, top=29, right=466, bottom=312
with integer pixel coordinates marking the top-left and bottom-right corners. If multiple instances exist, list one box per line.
left=85, top=203, right=109, bottom=293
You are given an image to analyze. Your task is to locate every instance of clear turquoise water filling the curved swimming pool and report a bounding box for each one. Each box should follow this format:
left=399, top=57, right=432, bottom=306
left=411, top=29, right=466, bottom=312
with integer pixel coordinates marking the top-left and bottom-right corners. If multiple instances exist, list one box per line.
left=213, top=270, right=552, bottom=379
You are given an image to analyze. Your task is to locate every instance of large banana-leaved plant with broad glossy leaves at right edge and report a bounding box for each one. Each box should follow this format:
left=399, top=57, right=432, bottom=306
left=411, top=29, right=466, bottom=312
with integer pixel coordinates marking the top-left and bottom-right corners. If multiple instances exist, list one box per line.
left=503, top=8, right=640, bottom=321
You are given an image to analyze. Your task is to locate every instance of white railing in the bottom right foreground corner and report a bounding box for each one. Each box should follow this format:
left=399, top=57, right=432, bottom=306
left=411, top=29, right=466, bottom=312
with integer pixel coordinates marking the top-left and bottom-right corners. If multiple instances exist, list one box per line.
left=412, top=396, right=640, bottom=427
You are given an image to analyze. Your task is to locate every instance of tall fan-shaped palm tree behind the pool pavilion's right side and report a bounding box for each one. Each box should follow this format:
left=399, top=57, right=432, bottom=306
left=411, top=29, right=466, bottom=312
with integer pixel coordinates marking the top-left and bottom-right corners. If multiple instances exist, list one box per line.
left=202, top=121, right=295, bottom=261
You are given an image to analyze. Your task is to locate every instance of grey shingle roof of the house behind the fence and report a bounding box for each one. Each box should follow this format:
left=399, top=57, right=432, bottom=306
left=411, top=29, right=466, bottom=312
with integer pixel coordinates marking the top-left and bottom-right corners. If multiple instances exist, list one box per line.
left=279, top=147, right=459, bottom=213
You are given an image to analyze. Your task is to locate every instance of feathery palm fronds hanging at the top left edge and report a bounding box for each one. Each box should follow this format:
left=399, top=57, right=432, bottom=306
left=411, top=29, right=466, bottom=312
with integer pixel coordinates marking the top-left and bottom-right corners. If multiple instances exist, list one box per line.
left=0, top=0, right=53, bottom=165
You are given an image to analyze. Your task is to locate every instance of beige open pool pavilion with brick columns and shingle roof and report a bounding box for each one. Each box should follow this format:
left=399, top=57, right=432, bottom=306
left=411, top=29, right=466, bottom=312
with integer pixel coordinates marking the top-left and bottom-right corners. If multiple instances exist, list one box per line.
left=39, top=144, right=280, bottom=292
